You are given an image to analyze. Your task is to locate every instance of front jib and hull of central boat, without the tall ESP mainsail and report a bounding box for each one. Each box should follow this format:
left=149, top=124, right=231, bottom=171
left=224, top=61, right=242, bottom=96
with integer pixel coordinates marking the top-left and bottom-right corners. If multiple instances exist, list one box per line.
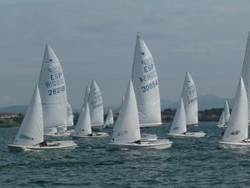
left=109, top=80, right=172, bottom=149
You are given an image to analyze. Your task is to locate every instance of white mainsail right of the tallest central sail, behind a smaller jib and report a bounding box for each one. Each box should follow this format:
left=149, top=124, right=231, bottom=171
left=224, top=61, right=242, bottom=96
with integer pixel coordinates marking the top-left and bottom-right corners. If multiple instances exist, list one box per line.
left=182, top=72, right=198, bottom=125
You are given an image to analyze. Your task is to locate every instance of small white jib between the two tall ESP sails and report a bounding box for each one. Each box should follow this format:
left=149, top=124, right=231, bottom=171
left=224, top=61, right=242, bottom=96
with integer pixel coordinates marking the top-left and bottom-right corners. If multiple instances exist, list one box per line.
left=75, top=103, right=92, bottom=136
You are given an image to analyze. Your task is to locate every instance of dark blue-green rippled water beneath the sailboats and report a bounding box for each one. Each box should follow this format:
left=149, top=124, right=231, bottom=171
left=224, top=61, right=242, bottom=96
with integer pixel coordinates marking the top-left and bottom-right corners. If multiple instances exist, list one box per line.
left=0, top=123, right=250, bottom=188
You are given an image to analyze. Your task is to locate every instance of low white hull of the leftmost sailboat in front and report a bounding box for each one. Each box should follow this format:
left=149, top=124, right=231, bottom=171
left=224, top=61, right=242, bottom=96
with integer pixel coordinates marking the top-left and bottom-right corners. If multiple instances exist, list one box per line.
left=8, top=140, right=77, bottom=151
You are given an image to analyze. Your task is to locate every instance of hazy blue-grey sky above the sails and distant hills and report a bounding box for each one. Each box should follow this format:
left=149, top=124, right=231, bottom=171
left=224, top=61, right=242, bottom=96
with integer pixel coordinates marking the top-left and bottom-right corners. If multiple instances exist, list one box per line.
left=0, top=0, right=250, bottom=108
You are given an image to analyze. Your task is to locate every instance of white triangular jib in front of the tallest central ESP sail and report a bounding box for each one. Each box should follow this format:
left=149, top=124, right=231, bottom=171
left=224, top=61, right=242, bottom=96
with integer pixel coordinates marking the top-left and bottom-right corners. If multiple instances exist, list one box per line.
left=112, top=81, right=141, bottom=144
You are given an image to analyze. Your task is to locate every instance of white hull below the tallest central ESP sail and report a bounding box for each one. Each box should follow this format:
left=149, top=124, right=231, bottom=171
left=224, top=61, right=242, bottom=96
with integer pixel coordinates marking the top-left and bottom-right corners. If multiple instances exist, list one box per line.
left=109, top=139, right=173, bottom=149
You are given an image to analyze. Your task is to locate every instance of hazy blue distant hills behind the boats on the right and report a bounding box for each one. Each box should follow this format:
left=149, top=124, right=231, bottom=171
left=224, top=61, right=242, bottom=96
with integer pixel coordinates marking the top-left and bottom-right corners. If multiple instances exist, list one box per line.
left=161, top=94, right=233, bottom=110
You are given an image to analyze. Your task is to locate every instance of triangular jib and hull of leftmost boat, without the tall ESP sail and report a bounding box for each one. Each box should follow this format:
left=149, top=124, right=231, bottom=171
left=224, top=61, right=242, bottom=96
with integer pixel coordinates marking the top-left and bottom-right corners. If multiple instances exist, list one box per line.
left=8, top=87, right=77, bottom=151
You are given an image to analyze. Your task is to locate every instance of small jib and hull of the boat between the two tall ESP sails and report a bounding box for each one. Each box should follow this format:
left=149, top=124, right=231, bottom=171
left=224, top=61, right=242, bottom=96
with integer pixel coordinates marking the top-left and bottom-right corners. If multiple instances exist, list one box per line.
left=71, top=87, right=108, bottom=138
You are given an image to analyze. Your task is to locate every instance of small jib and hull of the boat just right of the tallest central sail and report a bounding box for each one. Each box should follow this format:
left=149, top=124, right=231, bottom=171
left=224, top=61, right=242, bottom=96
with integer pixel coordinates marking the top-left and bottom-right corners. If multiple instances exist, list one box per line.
left=168, top=98, right=206, bottom=137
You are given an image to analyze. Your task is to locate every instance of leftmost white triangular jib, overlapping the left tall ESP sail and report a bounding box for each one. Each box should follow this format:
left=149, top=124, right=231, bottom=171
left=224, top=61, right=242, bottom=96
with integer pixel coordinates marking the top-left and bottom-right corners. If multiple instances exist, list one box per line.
left=14, top=86, right=44, bottom=145
